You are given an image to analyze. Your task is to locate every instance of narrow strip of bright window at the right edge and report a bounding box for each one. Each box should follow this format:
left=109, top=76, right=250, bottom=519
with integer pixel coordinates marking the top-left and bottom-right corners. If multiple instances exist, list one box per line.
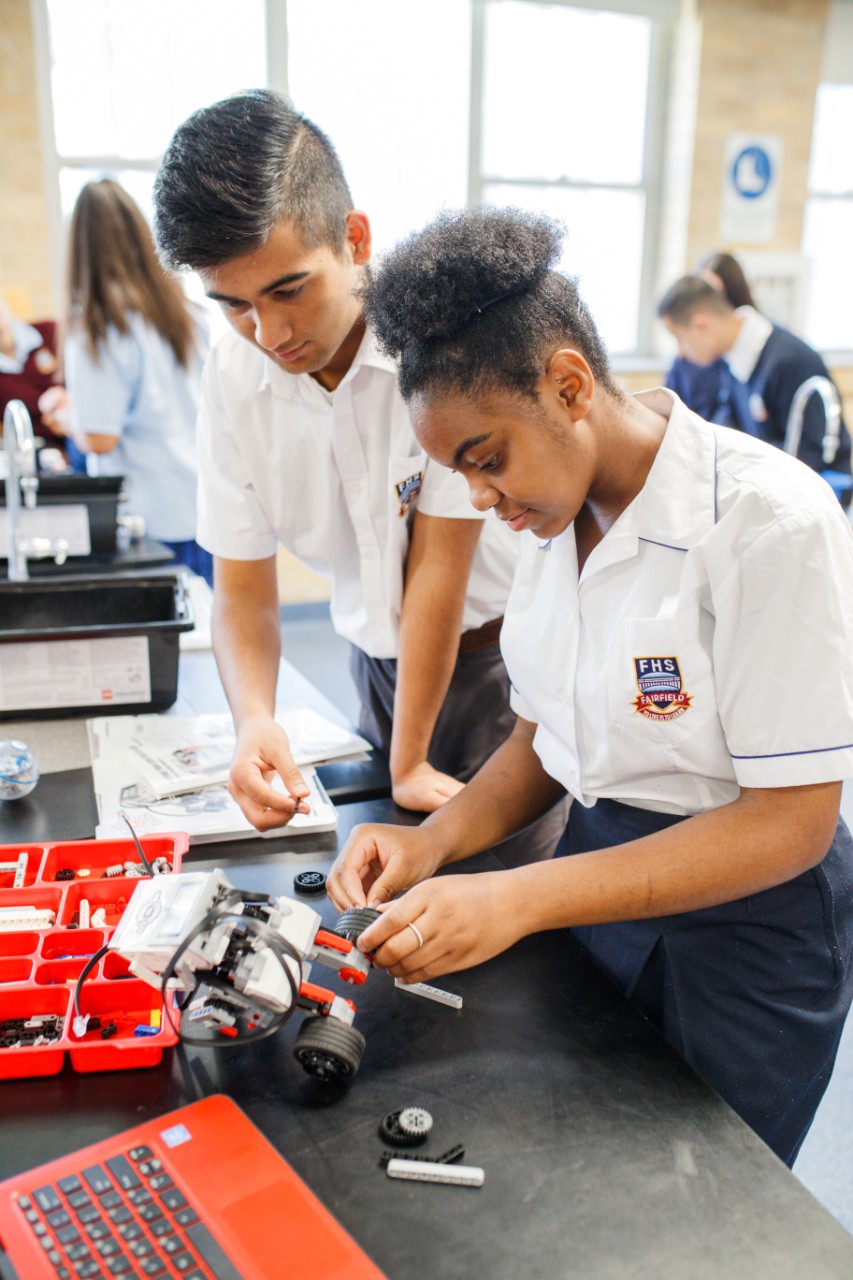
left=803, top=84, right=853, bottom=351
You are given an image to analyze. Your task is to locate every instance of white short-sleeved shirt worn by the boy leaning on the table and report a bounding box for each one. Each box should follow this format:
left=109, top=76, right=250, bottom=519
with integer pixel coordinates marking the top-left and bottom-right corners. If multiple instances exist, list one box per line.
left=199, top=332, right=517, bottom=658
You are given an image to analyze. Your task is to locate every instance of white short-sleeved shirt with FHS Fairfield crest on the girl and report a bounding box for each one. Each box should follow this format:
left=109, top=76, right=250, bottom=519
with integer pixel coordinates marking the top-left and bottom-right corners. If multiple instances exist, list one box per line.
left=501, top=390, right=853, bottom=814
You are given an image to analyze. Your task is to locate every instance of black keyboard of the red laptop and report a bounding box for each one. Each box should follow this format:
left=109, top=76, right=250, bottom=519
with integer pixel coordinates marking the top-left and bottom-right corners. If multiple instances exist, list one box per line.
left=18, top=1146, right=241, bottom=1280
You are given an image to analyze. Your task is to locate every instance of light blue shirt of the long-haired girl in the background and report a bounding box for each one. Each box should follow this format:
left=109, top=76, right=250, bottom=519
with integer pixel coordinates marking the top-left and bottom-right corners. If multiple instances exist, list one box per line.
left=64, top=312, right=207, bottom=543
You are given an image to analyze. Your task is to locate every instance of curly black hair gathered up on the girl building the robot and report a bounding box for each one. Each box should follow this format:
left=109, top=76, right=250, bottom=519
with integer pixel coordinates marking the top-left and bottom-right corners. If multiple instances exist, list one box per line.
left=365, top=209, right=622, bottom=399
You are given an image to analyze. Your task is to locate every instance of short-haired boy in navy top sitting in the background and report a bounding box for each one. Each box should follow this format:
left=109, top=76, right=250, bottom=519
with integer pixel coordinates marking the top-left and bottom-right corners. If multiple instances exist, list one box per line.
left=657, top=275, right=850, bottom=472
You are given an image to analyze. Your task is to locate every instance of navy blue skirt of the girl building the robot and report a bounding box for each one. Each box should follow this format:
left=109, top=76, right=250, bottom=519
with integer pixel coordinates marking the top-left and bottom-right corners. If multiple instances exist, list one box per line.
left=560, top=800, right=853, bottom=1165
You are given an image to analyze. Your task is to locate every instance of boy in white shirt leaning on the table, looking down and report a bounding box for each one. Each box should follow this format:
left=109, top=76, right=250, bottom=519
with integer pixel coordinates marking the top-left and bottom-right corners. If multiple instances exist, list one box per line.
left=155, top=90, right=560, bottom=852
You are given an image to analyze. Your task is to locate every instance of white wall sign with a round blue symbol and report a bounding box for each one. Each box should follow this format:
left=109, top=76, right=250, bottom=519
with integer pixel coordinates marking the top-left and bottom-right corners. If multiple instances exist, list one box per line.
left=720, top=133, right=783, bottom=243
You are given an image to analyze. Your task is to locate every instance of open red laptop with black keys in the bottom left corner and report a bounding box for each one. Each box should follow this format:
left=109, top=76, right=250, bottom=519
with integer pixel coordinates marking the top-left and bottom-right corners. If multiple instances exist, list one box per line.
left=0, top=1094, right=386, bottom=1280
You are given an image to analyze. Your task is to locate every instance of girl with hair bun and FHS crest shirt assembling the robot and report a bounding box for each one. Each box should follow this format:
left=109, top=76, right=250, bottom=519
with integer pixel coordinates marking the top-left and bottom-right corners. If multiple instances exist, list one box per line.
left=329, top=210, right=853, bottom=1162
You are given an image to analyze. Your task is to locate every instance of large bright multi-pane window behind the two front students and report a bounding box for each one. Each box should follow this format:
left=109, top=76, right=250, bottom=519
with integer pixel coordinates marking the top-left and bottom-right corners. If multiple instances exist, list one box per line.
left=38, top=0, right=663, bottom=353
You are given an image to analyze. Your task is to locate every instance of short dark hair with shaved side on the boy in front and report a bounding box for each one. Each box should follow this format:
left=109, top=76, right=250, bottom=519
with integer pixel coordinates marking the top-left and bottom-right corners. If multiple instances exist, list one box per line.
left=154, top=88, right=352, bottom=270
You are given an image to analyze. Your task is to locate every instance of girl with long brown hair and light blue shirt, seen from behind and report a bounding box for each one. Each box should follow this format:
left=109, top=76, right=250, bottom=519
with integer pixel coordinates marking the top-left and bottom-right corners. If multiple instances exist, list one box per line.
left=51, top=179, right=213, bottom=581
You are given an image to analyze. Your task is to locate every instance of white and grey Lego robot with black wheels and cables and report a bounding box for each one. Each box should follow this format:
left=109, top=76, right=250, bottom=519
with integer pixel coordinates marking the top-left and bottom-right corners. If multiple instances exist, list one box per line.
left=108, top=870, right=378, bottom=1080
